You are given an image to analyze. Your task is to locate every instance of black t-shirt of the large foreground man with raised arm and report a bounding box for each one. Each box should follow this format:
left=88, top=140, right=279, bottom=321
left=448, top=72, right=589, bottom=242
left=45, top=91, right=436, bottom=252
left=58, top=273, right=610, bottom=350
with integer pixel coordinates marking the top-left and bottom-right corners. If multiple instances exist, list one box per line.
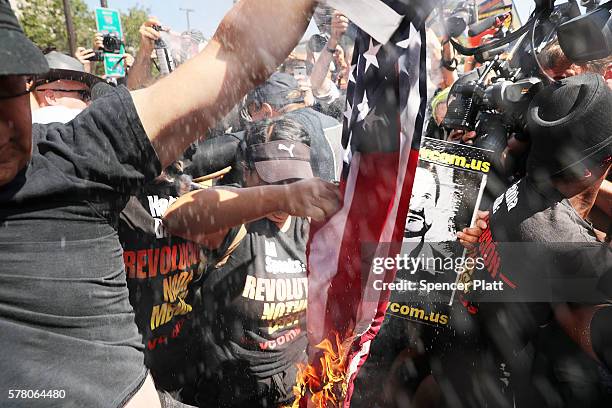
left=0, top=87, right=160, bottom=407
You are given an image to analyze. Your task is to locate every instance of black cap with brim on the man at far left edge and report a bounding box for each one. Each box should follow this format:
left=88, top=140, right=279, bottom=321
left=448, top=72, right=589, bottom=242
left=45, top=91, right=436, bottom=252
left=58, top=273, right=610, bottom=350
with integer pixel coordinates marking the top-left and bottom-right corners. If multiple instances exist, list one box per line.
left=0, top=0, right=49, bottom=76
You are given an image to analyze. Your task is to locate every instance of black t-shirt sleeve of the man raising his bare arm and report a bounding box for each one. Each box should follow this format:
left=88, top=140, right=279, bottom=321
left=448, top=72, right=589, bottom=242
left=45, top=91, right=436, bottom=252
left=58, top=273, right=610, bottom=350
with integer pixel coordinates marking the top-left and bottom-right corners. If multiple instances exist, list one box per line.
left=34, top=86, right=161, bottom=198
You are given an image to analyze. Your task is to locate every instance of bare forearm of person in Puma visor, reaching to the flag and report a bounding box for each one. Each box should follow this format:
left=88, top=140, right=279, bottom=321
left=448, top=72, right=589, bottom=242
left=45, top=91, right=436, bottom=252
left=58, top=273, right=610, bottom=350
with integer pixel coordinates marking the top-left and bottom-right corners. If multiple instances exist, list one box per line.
left=164, top=179, right=340, bottom=243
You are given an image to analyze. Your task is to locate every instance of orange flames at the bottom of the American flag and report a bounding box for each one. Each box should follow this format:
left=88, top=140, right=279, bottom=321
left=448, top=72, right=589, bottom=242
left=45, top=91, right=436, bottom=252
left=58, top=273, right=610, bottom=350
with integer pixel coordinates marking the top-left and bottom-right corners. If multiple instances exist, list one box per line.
left=292, top=333, right=350, bottom=408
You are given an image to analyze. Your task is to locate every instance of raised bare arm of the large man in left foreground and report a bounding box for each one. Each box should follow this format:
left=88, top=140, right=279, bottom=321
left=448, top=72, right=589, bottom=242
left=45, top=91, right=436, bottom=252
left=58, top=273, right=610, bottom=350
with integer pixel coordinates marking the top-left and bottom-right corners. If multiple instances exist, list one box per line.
left=133, top=0, right=316, bottom=167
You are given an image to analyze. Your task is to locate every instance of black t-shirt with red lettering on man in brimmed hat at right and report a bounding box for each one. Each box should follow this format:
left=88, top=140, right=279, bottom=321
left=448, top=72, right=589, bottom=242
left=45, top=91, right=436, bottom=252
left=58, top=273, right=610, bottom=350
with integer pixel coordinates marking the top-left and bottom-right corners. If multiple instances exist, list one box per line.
left=467, top=178, right=611, bottom=354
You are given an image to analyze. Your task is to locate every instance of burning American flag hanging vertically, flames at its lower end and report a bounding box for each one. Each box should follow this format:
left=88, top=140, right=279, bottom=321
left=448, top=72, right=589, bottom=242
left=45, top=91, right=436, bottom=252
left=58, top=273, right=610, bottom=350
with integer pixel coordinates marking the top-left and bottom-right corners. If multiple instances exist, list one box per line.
left=293, top=0, right=436, bottom=408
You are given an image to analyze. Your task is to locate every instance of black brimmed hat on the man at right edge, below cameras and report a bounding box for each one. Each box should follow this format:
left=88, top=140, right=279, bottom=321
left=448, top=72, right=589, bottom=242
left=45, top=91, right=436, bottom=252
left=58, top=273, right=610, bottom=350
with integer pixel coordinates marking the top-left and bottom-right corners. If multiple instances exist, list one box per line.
left=527, top=74, right=612, bottom=180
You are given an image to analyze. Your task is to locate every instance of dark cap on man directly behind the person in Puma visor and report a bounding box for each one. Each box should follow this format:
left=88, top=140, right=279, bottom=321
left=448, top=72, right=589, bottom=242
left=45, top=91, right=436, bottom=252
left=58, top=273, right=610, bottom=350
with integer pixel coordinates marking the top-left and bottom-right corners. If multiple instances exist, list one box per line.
left=246, top=72, right=304, bottom=107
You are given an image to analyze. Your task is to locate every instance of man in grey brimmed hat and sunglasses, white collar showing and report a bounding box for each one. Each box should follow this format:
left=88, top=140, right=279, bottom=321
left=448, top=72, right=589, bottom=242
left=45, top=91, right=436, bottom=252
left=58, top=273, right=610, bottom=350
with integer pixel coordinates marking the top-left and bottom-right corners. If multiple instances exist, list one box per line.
left=32, top=51, right=102, bottom=124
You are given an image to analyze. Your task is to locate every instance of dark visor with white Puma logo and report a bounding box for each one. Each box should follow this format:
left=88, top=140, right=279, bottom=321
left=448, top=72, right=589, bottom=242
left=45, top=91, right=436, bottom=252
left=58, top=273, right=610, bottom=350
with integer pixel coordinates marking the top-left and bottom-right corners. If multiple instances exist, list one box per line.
left=246, top=140, right=314, bottom=184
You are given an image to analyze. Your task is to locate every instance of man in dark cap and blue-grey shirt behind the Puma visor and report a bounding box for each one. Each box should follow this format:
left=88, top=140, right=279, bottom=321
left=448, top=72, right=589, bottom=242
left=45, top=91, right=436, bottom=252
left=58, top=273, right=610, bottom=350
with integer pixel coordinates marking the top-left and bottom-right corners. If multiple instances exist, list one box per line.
left=246, top=72, right=342, bottom=181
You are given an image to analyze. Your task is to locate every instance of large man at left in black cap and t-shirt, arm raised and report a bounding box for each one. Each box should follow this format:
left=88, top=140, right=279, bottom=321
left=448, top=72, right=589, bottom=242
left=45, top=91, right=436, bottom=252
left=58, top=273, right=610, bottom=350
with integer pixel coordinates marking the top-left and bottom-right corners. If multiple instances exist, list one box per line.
left=0, top=0, right=334, bottom=408
